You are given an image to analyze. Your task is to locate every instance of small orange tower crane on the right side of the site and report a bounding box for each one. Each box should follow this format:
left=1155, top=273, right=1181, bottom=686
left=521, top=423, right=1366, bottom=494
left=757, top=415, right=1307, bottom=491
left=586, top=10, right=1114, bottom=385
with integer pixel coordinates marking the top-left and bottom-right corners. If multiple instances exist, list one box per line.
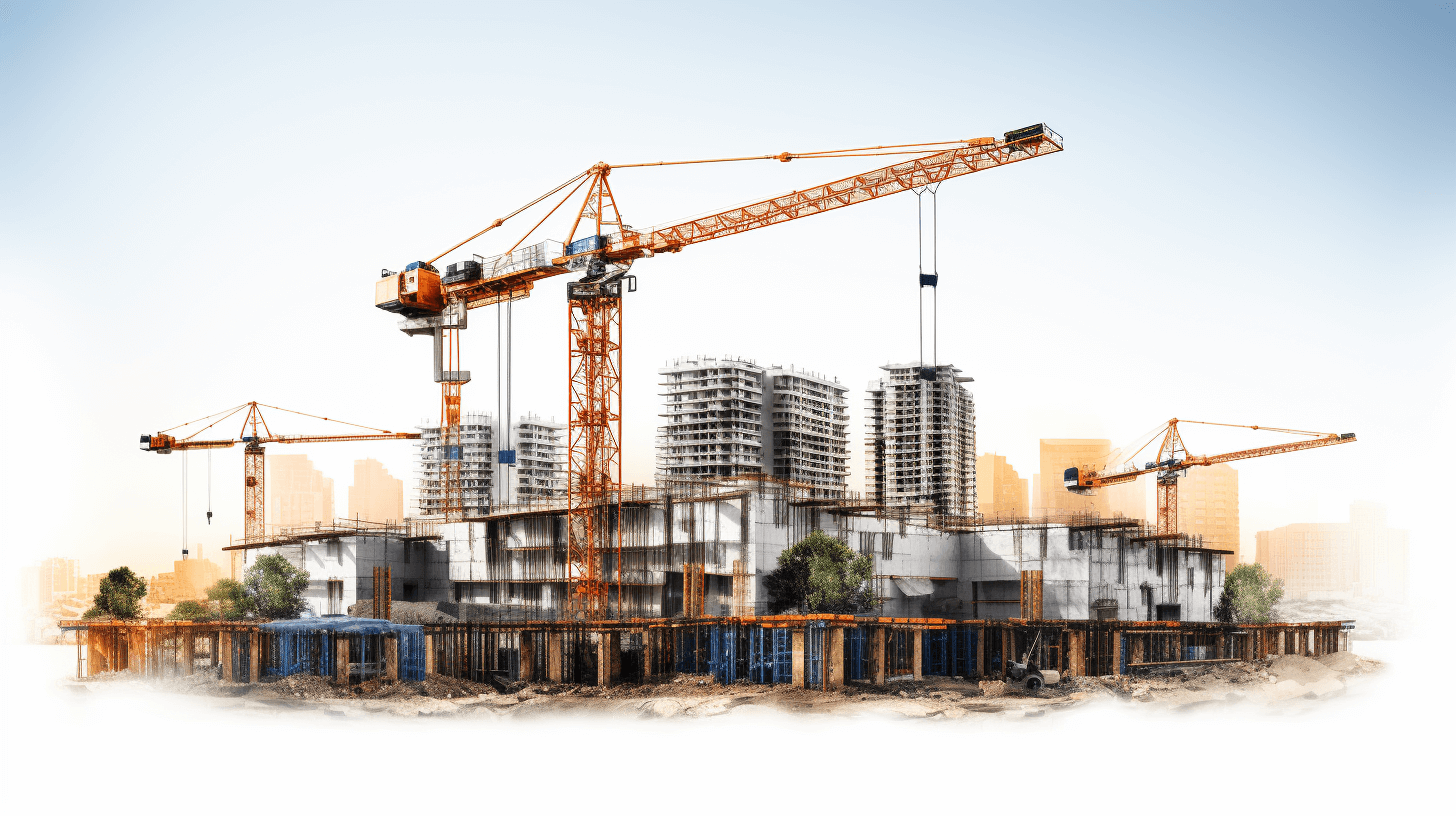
left=1061, top=418, right=1356, bottom=538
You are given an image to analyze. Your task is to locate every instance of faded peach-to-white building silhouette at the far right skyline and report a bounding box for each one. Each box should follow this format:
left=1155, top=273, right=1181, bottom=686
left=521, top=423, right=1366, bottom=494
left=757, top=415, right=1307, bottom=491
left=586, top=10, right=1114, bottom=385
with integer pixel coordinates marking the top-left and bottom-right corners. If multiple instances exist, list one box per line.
left=1254, top=501, right=1409, bottom=603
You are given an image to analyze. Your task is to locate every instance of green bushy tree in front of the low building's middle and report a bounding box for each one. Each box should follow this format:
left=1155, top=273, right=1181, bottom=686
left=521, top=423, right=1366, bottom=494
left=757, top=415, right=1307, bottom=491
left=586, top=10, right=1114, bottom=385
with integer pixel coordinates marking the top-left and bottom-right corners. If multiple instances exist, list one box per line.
left=763, top=530, right=879, bottom=615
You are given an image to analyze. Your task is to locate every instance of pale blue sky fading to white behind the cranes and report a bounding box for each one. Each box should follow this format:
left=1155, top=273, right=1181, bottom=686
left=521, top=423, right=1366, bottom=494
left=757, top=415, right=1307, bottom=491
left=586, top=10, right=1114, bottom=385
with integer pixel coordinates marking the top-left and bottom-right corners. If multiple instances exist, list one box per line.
left=0, top=1, right=1456, bottom=571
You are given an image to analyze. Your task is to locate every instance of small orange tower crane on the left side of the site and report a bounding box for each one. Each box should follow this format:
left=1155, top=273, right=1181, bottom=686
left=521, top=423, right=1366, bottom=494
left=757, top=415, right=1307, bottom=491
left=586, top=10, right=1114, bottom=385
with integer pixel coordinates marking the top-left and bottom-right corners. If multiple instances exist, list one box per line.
left=141, top=402, right=419, bottom=544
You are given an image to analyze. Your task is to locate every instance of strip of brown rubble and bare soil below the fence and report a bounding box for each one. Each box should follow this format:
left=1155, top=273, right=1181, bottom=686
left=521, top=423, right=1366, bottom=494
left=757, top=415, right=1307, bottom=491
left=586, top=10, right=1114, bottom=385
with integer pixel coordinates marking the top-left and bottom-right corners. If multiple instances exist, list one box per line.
left=70, top=653, right=1383, bottom=720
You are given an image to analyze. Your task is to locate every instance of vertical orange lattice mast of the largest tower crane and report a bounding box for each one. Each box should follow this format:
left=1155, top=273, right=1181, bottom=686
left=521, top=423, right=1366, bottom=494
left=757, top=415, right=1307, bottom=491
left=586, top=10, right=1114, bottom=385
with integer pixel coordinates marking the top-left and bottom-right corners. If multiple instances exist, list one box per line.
left=566, top=281, right=622, bottom=619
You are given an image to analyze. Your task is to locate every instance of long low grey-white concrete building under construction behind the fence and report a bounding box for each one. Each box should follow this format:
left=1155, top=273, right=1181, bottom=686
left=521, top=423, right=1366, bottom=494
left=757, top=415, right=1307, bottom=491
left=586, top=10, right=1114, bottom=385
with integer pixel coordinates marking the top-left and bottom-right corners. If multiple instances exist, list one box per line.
left=234, top=476, right=1223, bottom=621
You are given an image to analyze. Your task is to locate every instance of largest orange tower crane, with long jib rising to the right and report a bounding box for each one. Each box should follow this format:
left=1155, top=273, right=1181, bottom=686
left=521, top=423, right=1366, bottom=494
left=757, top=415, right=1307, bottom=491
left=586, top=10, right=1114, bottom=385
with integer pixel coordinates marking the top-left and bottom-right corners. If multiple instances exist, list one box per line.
left=374, top=124, right=1063, bottom=618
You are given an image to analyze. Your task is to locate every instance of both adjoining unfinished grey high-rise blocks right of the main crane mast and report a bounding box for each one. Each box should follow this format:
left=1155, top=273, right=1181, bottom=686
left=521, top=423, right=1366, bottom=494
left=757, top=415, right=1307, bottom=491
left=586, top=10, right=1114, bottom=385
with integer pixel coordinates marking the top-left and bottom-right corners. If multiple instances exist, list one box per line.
left=657, top=357, right=849, bottom=495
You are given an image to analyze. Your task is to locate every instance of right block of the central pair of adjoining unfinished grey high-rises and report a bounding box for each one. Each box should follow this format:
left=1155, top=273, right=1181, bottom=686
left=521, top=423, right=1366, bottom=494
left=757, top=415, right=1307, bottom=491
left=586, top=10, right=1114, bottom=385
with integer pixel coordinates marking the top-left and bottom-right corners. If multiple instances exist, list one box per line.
left=763, top=366, right=849, bottom=495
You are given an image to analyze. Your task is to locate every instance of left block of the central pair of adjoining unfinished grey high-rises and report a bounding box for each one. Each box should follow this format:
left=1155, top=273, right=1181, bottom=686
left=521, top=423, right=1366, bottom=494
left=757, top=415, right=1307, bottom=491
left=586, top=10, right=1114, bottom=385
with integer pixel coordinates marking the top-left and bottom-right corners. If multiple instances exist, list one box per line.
left=657, top=357, right=764, bottom=479
